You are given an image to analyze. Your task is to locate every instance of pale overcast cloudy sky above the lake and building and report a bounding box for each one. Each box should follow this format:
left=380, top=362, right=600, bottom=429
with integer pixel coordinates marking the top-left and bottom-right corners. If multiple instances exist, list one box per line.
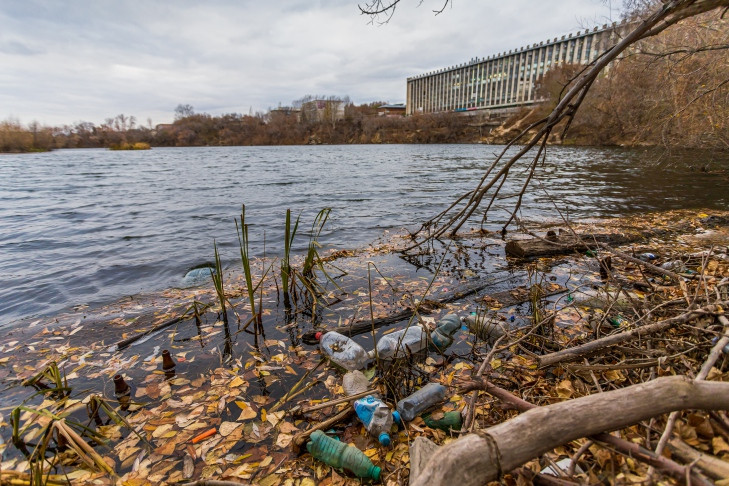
left=0, top=0, right=618, bottom=125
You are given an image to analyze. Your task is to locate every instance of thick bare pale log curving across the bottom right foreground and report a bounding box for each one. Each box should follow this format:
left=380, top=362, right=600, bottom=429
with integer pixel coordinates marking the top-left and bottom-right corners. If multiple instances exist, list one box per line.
left=410, top=376, right=729, bottom=486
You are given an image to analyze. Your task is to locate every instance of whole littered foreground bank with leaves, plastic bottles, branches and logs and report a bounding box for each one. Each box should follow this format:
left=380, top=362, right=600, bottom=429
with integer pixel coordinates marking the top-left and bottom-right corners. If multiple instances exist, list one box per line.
left=0, top=213, right=729, bottom=486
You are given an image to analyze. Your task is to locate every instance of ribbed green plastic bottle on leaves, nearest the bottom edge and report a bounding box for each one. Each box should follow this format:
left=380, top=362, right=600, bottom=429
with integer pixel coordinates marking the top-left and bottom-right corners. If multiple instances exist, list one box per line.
left=306, top=430, right=380, bottom=481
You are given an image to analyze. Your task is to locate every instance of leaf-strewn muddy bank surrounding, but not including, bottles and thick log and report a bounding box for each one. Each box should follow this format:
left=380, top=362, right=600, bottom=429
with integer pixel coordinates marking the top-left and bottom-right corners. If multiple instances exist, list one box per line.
left=0, top=211, right=729, bottom=485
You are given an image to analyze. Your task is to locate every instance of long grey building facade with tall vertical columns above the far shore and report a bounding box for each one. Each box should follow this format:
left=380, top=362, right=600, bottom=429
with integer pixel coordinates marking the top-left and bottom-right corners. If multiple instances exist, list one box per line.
left=406, top=19, right=625, bottom=115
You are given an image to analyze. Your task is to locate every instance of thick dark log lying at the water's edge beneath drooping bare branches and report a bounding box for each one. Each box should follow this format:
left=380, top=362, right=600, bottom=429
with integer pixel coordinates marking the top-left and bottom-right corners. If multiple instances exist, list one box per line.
left=506, top=234, right=645, bottom=258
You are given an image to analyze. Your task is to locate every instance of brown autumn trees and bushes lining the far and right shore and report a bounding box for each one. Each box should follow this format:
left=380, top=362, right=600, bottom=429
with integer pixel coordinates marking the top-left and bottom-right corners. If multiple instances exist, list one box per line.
left=0, top=6, right=729, bottom=152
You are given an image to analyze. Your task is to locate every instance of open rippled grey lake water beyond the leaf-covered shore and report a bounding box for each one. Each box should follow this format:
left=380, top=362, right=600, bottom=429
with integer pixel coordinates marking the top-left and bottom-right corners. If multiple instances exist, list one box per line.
left=0, top=145, right=729, bottom=326
